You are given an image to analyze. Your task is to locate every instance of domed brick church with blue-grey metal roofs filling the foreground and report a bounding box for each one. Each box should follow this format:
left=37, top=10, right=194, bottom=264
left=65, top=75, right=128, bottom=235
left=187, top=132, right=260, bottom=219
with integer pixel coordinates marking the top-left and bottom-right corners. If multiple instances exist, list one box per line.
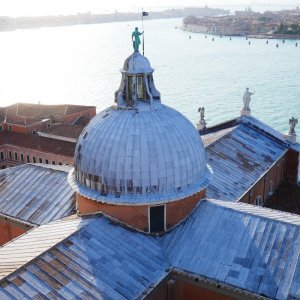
left=0, top=48, right=300, bottom=300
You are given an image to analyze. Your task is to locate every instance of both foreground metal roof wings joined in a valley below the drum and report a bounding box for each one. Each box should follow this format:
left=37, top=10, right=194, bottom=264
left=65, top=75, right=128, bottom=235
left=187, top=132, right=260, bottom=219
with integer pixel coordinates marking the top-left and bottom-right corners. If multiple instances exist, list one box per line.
left=0, top=200, right=300, bottom=299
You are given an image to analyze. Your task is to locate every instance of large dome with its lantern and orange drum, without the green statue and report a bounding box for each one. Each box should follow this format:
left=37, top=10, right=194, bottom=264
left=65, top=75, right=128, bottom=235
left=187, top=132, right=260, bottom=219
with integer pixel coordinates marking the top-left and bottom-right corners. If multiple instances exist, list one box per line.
left=69, top=47, right=212, bottom=234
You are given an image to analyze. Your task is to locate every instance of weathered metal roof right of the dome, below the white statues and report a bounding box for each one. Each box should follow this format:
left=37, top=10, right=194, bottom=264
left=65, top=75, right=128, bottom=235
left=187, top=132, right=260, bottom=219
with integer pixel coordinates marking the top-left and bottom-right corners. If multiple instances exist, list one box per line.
left=202, top=123, right=288, bottom=201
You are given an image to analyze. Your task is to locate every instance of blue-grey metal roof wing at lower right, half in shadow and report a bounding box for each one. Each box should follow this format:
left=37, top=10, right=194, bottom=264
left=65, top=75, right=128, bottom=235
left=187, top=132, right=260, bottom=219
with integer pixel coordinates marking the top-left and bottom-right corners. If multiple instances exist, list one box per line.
left=162, top=200, right=300, bottom=299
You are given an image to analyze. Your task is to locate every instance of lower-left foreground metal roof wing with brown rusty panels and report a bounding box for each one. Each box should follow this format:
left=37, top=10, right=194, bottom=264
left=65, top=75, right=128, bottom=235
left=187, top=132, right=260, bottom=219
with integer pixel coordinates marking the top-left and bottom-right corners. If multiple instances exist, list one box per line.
left=0, top=216, right=169, bottom=299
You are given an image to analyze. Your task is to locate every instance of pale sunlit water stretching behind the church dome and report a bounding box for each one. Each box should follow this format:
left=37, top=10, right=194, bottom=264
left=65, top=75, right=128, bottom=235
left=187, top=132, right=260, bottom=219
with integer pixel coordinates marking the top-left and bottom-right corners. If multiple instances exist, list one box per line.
left=0, top=19, right=300, bottom=131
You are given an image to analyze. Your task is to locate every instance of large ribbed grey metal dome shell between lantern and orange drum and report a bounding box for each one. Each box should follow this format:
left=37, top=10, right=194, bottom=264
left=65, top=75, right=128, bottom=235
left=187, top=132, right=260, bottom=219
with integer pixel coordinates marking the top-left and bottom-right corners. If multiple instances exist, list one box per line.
left=71, top=104, right=211, bottom=204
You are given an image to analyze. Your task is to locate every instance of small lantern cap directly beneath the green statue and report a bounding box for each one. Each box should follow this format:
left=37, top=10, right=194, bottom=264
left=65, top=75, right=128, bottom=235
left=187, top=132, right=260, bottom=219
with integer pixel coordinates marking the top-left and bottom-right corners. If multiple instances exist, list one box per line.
left=121, top=52, right=154, bottom=74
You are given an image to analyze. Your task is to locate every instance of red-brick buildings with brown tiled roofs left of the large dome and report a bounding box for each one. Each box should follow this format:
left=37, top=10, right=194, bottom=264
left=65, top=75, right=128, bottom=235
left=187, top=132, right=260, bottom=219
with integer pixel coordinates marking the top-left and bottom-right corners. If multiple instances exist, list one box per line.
left=0, top=103, right=96, bottom=169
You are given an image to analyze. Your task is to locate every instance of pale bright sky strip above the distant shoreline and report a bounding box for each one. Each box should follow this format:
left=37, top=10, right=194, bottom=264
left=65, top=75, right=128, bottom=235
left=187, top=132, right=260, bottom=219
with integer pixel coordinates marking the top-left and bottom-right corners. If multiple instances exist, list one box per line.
left=0, top=0, right=300, bottom=17
